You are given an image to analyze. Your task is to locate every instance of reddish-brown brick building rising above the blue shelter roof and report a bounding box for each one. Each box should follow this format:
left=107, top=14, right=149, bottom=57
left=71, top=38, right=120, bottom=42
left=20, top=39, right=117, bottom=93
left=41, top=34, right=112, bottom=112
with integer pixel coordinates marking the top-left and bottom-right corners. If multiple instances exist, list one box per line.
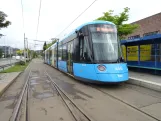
left=126, top=12, right=161, bottom=39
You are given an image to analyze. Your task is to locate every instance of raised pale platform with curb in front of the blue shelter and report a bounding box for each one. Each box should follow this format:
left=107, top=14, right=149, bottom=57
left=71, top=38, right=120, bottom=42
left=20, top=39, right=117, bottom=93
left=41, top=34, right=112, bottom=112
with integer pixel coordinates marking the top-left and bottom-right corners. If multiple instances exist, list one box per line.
left=128, top=71, right=161, bottom=92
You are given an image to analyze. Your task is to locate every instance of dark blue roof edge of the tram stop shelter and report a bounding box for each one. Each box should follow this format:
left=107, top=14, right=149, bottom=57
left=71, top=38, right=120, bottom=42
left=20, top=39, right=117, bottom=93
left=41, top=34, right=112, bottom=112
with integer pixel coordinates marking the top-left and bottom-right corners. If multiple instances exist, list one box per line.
left=121, top=34, right=161, bottom=46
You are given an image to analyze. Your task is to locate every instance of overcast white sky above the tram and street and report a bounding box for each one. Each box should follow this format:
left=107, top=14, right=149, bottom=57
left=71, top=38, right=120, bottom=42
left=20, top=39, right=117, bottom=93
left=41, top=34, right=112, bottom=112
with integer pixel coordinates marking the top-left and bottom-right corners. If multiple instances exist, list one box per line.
left=0, top=0, right=161, bottom=50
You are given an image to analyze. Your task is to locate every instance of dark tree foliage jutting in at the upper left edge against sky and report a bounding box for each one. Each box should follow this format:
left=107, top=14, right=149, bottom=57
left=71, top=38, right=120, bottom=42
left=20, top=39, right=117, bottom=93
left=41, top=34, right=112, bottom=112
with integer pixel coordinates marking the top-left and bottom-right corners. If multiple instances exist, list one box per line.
left=0, top=11, right=11, bottom=37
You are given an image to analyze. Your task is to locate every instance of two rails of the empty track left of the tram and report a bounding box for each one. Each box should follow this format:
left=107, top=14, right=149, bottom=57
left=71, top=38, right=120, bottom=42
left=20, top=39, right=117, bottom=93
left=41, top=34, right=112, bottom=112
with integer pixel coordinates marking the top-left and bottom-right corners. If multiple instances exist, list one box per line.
left=10, top=70, right=94, bottom=121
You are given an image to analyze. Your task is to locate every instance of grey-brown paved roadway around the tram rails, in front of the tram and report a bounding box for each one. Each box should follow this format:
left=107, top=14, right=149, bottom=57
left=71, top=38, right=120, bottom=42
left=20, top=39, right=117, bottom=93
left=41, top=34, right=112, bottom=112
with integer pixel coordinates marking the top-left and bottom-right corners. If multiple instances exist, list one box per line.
left=0, top=59, right=161, bottom=121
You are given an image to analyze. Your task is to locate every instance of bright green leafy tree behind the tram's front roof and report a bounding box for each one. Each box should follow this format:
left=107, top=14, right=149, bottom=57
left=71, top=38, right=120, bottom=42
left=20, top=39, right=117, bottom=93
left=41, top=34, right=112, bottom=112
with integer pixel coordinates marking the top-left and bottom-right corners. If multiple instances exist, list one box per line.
left=97, top=7, right=138, bottom=39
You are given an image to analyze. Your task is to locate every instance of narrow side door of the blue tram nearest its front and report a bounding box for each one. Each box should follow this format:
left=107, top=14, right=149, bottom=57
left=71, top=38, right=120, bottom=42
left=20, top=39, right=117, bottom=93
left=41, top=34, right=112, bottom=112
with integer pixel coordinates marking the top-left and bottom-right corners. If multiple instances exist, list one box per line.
left=67, top=42, right=73, bottom=74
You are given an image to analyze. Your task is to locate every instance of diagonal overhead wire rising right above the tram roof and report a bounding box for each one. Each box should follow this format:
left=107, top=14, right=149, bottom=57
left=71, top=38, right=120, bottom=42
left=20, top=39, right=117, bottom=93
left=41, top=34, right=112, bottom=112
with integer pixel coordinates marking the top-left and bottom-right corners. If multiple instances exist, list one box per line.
left=56, top=0, right=97, bottom=37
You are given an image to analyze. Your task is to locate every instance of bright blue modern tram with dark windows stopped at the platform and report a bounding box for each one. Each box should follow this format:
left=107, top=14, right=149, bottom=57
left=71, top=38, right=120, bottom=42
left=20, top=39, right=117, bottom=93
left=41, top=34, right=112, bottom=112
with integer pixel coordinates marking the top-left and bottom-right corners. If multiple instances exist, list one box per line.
left=45, top=21, right=128, bottom=83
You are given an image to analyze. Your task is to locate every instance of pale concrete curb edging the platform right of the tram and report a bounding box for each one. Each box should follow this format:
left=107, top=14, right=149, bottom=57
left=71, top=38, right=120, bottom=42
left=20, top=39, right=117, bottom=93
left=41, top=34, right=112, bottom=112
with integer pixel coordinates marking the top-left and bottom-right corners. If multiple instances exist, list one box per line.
left=127, top=77, right=161, bottom=92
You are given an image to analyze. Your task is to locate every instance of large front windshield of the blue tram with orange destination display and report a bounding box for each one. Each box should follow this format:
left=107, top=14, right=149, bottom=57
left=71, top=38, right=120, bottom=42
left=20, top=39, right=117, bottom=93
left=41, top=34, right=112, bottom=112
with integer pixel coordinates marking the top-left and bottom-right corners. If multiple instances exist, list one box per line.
left=91, top=25, right=121, bottom=62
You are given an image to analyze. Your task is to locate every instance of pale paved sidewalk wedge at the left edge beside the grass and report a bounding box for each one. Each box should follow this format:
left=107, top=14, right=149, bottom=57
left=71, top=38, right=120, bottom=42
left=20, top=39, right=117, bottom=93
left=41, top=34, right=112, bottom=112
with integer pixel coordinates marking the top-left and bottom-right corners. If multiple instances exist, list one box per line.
left=0, top=72, right=21, bottom=96
